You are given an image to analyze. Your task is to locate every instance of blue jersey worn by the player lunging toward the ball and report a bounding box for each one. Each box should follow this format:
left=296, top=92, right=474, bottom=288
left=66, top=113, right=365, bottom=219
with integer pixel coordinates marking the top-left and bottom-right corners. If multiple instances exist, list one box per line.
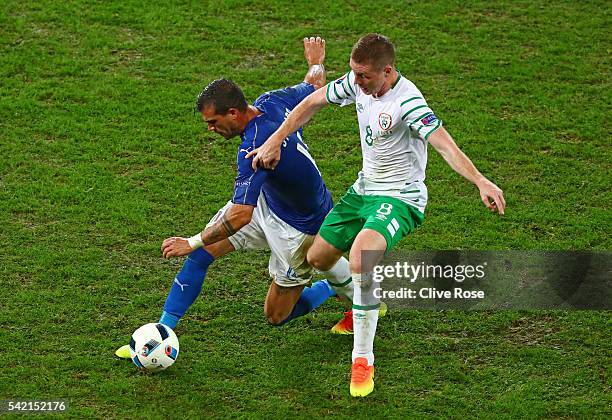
left=232, top=83, right=333, bottom=235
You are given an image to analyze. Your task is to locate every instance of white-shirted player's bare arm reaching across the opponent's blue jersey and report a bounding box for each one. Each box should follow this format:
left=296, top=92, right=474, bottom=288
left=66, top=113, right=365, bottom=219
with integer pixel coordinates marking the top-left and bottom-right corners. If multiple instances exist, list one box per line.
left=245, top=87, right=327, bottom=170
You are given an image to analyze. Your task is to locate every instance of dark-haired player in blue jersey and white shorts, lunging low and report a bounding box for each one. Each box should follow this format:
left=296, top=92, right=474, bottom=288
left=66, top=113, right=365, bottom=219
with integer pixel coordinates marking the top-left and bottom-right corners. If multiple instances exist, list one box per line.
left=117, top=37, right=352, bottom=357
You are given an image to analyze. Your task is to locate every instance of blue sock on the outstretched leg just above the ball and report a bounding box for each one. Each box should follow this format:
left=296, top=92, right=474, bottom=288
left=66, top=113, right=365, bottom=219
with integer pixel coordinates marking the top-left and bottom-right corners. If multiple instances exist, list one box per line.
left=159, top=248, right=215, bottom=328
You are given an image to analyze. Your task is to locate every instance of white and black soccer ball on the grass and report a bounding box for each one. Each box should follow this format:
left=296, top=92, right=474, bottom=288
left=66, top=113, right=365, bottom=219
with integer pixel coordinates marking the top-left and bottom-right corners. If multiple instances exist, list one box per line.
left=130, top=323, right=179, bottom=372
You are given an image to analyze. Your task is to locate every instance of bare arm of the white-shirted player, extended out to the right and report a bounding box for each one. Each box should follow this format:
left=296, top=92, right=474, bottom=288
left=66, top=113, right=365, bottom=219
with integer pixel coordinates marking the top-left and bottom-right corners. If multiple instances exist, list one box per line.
left=429, top=127, right=506, bottom=214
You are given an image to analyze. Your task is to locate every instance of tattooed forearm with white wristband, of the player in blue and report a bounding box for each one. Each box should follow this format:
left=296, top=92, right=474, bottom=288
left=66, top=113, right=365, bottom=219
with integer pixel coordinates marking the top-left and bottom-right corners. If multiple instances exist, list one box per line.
left=161, top=204, right=255, bottom=258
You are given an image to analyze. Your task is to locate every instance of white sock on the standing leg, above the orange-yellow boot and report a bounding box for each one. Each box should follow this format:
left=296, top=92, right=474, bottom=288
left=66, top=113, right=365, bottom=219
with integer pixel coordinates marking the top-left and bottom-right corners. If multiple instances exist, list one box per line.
left=352, top=273, right=380, bottom=365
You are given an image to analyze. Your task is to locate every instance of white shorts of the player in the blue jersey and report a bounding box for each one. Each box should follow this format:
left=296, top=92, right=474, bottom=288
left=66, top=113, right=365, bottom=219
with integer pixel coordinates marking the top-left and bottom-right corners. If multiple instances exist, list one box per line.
left=206, top=194, right=314, bottom=287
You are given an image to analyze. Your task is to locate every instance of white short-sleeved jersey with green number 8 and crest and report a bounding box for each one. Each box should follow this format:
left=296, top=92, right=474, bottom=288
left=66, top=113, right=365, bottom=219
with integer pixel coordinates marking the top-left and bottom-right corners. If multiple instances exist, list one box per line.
left=326, top=71, right=442, bottom=213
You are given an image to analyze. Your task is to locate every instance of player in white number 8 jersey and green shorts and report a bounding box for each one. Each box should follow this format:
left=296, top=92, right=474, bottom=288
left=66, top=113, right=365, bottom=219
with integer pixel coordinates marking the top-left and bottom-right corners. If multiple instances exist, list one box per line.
left=250, top=34, right=506, bottom=396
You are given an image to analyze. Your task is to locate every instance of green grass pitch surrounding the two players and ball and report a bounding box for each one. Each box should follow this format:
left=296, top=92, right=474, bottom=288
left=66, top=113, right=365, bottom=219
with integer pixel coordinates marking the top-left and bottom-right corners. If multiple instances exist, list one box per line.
left=0, top=0, right=612, bottom=418
